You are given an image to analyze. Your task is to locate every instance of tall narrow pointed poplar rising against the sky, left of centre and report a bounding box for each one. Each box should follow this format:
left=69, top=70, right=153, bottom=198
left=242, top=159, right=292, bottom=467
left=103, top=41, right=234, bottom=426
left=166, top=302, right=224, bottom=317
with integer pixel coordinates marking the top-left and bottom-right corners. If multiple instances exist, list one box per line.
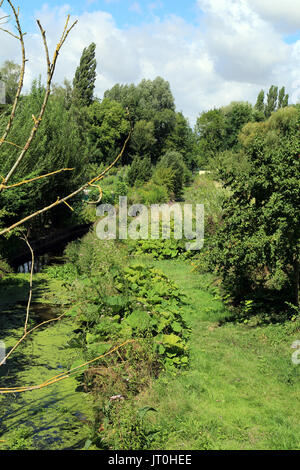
left=73, top=42, right=97, bottom=107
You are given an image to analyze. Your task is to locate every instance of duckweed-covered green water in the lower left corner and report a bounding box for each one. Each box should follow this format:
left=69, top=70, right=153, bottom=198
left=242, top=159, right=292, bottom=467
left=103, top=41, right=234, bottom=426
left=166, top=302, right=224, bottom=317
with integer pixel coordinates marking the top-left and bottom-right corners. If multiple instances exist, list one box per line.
left=0, top=304, right=92, bottom=450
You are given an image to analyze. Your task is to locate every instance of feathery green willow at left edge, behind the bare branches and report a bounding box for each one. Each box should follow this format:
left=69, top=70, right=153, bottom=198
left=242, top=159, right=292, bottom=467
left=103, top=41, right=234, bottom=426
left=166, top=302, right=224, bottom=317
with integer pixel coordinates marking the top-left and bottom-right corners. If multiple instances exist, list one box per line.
left=0, top=82, right=85, bottom=234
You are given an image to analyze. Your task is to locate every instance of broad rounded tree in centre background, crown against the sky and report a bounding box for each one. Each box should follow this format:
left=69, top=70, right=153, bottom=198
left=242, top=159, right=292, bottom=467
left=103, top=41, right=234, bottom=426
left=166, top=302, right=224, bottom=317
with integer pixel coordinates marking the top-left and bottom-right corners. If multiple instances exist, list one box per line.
left=104, top=77, right=196, bottom=168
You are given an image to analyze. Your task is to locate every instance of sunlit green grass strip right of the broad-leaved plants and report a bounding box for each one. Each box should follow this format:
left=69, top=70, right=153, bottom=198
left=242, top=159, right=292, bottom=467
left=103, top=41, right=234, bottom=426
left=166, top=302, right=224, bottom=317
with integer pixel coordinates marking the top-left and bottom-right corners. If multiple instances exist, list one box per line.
left=132, top=261, right=300, bottom=450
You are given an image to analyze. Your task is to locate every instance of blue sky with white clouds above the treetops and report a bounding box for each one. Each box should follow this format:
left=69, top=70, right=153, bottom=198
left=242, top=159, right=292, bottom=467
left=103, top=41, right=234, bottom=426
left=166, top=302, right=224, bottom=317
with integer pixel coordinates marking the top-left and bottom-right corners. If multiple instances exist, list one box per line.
left=0, top=0, right=300, bottom=125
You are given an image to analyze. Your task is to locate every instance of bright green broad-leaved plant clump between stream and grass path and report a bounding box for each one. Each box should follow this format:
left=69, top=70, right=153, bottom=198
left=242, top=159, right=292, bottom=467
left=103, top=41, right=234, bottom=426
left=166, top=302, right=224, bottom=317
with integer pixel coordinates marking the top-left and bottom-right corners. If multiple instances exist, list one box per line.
left=68, top=264, right=188, bottom=368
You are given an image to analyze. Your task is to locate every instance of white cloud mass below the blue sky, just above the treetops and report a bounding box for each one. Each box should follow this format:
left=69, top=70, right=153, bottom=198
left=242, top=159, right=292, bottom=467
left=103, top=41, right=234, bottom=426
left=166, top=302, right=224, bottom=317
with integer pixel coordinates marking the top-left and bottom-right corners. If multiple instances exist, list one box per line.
left=0, top=0, right=300, bottom=124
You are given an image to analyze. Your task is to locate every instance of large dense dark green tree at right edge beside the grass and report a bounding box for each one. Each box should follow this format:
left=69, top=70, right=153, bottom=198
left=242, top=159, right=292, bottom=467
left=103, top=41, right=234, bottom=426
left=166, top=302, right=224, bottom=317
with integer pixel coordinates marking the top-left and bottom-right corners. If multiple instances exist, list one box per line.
left=212, top=106, right=300, bottom=309
